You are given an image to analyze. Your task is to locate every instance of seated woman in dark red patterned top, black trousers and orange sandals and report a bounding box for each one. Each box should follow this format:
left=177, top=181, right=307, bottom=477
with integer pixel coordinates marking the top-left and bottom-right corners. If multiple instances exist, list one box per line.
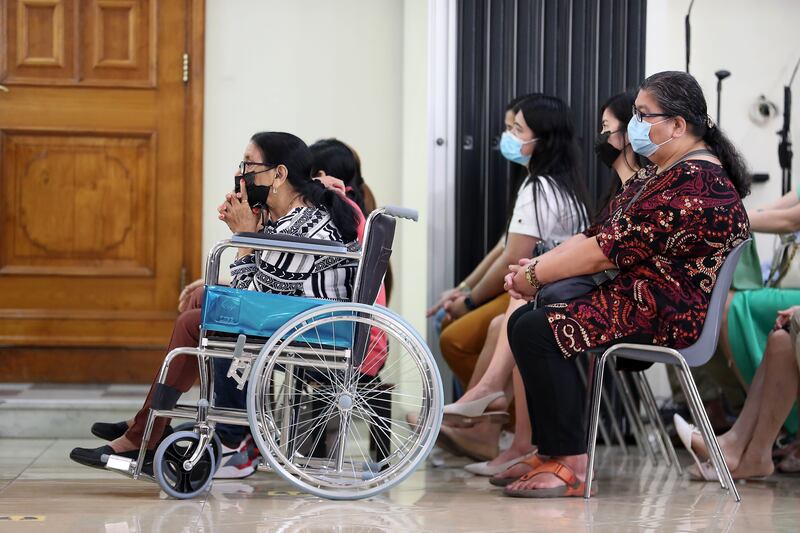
left=505, top=72, right=750, bottom=498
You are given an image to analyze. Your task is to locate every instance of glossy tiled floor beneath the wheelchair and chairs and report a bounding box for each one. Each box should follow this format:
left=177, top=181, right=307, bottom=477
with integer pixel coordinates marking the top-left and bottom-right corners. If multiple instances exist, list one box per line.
left=0, top=439, right=800, bottom=533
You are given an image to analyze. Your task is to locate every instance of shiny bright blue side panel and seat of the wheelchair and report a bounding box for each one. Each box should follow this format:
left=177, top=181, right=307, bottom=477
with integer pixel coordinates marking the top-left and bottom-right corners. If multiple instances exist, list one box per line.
left=200, top=285, right=353, bottom=349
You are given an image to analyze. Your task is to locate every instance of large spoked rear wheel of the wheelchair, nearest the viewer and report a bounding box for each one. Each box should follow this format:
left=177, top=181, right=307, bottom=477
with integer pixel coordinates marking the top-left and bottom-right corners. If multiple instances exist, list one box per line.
left=247, top=303, right=444, bottom=499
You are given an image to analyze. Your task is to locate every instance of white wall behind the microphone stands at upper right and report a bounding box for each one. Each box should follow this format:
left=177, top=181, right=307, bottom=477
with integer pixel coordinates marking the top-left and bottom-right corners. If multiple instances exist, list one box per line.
left=645, top=0, right=800, bottom=261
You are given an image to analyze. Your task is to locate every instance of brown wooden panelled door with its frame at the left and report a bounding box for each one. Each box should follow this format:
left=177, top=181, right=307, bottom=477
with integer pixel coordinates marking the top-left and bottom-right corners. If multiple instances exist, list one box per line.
left=0, top=0, right=203, bottom=382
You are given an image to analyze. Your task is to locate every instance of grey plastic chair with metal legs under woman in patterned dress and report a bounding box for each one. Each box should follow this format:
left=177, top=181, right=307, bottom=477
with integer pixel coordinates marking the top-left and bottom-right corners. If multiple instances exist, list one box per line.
left=584, top=239, right=750, bottom=502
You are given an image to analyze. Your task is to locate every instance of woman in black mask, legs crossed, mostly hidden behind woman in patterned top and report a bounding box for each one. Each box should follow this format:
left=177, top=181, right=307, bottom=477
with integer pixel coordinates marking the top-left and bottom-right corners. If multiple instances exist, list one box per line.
left=442, top=93, right=641, bottom=474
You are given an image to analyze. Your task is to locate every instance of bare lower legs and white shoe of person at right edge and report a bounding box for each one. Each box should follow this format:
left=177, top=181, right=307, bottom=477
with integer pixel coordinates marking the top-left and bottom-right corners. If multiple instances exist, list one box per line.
left=674, top=306, right=800, bottom=481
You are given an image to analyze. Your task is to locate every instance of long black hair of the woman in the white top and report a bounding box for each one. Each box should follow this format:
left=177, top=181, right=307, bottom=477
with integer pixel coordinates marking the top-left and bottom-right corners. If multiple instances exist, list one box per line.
left=514, top=95, right=590, bottom=232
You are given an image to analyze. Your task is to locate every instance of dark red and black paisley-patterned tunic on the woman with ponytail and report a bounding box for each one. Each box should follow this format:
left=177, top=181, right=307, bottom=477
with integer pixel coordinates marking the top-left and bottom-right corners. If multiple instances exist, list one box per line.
left=544, top=160, right=750, bottom=357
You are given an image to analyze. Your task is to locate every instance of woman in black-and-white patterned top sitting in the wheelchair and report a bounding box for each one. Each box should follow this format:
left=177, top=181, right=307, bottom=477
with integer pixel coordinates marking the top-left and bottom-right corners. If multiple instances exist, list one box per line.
left=70, top=132, right=358, bottom=468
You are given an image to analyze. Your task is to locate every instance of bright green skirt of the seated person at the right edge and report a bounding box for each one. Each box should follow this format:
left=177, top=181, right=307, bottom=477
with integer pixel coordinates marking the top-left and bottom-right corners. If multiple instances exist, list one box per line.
left=728, top=288, right=800, bottom=433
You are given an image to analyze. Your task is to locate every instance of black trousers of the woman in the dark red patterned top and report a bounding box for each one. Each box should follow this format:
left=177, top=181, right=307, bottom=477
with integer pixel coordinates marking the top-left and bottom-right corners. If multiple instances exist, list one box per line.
left=508, top=303, right=652, bottom=456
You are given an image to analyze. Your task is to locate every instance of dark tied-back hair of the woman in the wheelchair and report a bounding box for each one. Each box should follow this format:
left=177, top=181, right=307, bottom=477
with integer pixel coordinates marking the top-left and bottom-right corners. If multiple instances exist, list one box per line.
left=250, top=131, right=358, bottom=242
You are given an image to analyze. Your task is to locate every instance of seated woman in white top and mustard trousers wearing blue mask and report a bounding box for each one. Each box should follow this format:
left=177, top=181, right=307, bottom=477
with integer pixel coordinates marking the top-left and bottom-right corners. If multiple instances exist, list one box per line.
left=432, top=95, right=588, bottom=461
